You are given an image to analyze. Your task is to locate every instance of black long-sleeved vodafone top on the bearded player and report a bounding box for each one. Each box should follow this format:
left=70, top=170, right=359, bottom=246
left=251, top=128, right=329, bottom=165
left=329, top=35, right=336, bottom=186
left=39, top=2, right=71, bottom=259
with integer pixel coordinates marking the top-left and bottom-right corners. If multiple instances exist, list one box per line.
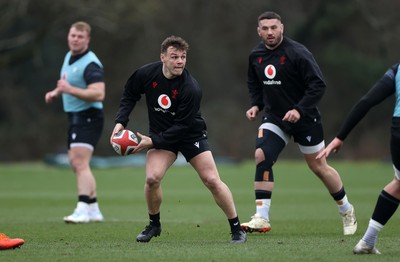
left=247, top=37, right=326, bottom=119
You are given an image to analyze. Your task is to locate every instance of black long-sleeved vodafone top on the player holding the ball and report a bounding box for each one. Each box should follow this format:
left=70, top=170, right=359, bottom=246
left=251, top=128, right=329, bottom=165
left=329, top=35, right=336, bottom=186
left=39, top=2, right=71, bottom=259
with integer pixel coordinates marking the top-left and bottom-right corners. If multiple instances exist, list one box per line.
left=115, top=61, right=206, bottom=148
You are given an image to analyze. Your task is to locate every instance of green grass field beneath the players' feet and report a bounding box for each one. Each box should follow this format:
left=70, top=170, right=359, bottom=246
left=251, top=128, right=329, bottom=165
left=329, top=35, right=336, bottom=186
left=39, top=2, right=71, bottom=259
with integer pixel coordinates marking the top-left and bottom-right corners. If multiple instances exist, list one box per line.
left=0, top=161, right=400, bottom=262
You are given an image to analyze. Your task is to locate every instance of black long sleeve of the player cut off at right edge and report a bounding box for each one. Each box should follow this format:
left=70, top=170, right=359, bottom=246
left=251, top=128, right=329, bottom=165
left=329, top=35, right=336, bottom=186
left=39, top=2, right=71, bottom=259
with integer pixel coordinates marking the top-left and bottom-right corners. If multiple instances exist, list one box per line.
left=336, top=63, right=400, bottom=141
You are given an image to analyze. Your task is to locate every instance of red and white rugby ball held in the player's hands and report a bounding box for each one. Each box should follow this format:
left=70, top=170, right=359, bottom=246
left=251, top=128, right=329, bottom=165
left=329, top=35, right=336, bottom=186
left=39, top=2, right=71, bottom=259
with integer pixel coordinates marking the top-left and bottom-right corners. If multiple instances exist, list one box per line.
left=111, top=129, right=139, bottom=156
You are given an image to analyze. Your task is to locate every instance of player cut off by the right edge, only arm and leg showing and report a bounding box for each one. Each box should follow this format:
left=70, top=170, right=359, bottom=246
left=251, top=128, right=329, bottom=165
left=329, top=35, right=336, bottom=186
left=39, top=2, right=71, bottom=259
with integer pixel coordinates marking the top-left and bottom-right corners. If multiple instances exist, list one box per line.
left=317, top=63, right=400, bottom=254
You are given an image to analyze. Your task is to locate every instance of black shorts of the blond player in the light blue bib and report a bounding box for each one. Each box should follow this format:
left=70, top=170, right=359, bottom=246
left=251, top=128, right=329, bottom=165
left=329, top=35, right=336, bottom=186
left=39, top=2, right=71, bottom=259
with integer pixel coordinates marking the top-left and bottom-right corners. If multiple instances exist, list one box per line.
left=67, top=108, right=104, bottom=150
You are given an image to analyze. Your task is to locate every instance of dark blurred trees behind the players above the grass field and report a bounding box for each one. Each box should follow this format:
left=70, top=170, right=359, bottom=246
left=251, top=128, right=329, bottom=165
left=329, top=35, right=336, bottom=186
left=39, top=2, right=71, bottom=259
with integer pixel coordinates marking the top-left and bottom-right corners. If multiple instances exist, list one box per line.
left=0, top=0, right=400, bottom=162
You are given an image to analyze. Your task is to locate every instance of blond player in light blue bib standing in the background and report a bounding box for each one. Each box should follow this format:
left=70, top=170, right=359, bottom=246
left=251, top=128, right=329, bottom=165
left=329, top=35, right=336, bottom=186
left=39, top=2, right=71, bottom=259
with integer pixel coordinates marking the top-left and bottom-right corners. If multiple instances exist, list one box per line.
left=45, top=22, right=105, bottom=223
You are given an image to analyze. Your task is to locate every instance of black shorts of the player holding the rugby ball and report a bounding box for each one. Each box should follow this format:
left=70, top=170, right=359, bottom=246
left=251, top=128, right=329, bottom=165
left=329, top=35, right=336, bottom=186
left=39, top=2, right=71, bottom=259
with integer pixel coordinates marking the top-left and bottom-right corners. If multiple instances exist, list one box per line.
left=157, top=138, right=210, bottom=162
